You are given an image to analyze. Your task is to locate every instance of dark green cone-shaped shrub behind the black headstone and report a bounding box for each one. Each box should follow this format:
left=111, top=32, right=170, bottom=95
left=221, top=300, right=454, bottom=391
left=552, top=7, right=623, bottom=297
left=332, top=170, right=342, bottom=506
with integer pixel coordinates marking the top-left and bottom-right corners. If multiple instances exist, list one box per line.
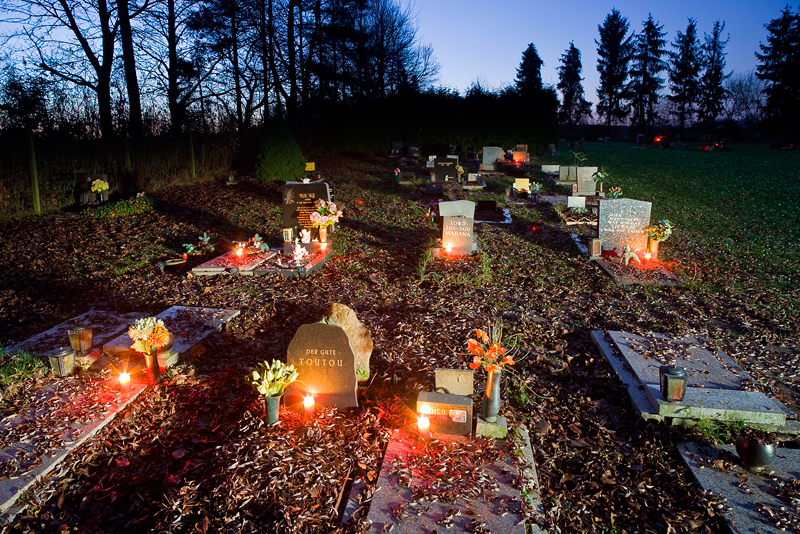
left=256, top=121, right=306, bottom=182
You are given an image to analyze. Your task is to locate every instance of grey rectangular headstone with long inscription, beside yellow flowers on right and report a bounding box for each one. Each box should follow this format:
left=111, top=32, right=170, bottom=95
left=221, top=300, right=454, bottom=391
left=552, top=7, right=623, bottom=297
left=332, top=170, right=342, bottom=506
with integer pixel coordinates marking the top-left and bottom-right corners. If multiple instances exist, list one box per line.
left=597, top=198, right=652, bottom=256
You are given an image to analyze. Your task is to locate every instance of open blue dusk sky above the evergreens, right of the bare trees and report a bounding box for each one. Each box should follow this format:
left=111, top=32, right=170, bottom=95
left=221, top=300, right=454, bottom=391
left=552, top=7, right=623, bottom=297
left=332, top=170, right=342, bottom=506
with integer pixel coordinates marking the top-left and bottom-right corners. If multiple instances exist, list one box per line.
left=414, top=0, right=796, bottom=102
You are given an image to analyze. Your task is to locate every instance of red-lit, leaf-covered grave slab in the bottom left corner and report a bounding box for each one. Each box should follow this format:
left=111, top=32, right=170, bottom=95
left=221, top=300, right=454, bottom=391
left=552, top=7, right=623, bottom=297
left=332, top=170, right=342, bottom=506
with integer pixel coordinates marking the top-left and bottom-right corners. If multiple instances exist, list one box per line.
left=0, top=373, right=147, bottom=524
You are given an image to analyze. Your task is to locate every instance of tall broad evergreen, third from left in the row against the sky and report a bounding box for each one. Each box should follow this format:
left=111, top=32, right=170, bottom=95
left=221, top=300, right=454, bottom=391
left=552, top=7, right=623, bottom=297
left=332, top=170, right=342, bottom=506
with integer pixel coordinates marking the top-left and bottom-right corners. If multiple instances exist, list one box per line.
left=595, top=9, right=633, bottom=133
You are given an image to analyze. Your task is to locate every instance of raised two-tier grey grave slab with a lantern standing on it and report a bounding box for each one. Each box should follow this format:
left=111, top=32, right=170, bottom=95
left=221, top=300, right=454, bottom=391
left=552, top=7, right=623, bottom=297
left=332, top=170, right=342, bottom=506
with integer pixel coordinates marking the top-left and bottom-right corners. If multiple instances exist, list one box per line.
left=592, top=330, right=797, bottom=432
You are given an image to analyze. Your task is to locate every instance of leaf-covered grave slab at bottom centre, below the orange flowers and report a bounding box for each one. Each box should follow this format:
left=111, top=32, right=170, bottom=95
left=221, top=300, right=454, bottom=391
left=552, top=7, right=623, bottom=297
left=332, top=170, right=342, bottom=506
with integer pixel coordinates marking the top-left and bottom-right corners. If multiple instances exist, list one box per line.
left=367, top=429, right=544, bottom=534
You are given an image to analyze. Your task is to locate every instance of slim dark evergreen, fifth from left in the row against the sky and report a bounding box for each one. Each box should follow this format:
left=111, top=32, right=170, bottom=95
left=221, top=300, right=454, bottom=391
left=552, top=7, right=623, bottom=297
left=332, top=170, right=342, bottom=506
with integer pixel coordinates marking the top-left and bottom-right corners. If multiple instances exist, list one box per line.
left=668, top=19, right=701, bottom=131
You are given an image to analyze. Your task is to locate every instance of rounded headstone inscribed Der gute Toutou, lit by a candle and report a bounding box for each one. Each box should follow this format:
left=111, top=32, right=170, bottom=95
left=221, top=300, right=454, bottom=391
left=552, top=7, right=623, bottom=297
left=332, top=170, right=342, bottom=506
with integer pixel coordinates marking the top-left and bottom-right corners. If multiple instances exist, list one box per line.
left=284, top=323, right=358, bottom=408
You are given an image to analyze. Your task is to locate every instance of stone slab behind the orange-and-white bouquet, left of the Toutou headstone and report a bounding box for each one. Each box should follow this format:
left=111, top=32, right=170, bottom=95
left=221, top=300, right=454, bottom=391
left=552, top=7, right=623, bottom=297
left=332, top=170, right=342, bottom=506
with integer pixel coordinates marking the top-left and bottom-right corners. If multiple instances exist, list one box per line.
left=103, top=306, right=239, bottom=357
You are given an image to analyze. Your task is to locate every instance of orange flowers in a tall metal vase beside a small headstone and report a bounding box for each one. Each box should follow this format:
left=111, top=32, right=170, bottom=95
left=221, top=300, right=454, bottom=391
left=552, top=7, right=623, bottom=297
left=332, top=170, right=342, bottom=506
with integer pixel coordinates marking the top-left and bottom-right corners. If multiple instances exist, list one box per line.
left=467, top=319, right=514, bottom=423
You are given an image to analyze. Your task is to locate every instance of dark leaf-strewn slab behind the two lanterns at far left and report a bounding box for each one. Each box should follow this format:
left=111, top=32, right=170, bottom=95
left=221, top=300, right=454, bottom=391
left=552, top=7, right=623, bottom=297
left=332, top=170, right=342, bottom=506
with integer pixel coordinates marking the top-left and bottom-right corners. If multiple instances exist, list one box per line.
left=5, top=310, right=141, bottom=356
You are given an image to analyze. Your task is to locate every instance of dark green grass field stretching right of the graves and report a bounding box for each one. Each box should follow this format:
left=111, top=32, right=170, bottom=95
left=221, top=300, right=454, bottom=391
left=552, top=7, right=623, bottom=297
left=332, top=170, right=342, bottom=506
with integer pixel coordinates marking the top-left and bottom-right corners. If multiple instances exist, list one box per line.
left=544, top=143, right=800, bottom=324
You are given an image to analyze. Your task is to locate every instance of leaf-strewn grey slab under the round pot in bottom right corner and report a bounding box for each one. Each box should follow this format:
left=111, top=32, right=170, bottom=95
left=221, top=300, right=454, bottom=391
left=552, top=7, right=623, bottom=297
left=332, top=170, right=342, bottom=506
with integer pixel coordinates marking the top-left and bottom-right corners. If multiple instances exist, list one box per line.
left=678, top=443, right=800, bottom=534
